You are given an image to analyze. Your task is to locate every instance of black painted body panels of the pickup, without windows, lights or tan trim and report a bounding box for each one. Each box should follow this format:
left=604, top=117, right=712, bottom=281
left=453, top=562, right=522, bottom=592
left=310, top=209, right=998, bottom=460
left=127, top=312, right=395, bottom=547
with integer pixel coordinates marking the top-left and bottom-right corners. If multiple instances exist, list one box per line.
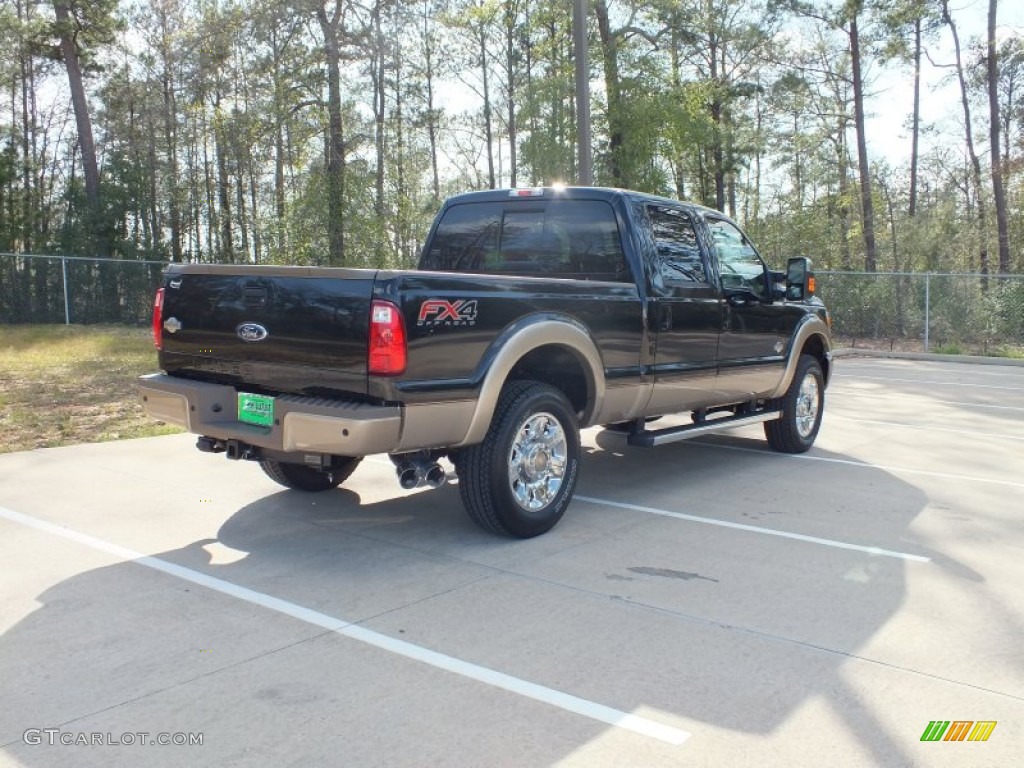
left=151, top=188, right=818, bottom=415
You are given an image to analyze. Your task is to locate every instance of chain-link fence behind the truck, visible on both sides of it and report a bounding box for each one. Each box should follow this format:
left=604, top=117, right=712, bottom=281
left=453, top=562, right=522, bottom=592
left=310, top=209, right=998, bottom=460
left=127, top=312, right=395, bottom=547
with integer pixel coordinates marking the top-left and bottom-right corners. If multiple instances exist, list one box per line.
left=0, top=254, right=1024, bottom=354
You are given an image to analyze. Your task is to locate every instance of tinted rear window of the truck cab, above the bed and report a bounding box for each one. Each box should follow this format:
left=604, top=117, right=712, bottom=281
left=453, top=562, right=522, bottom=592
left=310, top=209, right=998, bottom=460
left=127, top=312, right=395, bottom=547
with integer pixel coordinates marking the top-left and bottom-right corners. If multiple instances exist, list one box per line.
left=420, top=200, right=632, bottom=282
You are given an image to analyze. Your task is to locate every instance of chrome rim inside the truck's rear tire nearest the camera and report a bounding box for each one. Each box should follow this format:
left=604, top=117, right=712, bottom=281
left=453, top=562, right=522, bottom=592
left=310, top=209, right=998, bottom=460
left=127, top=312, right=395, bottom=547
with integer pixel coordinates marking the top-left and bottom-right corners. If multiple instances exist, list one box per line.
left=508, top=413, right=567, bottom=511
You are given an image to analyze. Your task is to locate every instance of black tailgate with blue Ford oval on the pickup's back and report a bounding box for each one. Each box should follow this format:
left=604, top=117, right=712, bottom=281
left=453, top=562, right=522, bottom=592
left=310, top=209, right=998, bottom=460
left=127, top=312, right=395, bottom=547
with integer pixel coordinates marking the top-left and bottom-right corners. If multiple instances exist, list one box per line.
left=160, top=264, right=376, bottom=394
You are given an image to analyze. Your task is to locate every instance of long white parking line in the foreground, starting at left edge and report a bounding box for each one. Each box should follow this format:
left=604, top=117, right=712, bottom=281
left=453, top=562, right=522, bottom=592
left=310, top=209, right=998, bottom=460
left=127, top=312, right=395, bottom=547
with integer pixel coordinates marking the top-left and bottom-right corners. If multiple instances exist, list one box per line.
left=0, top=507, right=690, bottom=745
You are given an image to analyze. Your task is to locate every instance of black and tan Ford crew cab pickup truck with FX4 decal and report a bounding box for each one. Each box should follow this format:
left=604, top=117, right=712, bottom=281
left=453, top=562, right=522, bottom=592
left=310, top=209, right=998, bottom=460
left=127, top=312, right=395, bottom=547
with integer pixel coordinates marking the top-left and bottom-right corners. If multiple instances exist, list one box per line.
left=139, top=187, right=831, bottom=538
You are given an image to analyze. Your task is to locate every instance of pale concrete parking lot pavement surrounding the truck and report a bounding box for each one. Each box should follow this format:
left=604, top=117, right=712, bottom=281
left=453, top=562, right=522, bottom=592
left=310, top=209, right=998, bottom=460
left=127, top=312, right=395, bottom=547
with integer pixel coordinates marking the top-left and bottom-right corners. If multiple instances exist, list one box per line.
left=0, top=358, right=1024, bottom=766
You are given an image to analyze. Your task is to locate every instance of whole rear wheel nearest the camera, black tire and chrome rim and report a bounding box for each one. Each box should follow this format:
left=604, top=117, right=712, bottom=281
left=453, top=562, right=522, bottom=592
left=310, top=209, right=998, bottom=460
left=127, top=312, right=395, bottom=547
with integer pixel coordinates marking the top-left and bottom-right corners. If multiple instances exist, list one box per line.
left=457, top=381, right=580, bottom=539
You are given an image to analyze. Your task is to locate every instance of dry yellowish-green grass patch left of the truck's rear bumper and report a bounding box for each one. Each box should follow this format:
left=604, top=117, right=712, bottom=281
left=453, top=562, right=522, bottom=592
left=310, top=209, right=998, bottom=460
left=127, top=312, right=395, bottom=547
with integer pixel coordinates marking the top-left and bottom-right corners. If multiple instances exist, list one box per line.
left=0, top=326, right=181, bottom=454
